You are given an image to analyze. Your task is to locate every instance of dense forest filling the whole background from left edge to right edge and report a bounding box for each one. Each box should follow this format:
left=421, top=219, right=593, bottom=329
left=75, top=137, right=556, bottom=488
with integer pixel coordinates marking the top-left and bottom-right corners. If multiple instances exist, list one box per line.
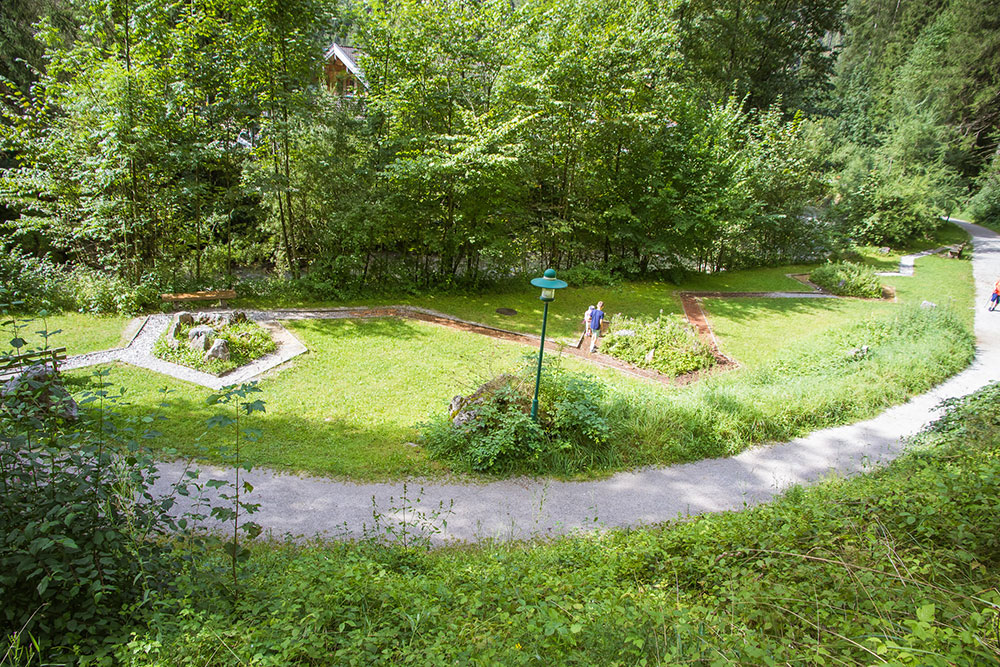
left=0, top=0, right=1000, bottom=305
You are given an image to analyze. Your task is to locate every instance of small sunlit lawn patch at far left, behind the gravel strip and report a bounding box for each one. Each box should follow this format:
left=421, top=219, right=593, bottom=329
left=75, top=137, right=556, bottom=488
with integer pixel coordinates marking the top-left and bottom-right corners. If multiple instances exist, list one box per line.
left=0, top=311, right=130, bottom=354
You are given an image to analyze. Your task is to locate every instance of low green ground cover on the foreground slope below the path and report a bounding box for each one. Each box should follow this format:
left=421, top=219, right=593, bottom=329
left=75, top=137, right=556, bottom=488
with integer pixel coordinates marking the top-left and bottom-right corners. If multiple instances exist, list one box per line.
left=109, top=378, right=1000, bottom=667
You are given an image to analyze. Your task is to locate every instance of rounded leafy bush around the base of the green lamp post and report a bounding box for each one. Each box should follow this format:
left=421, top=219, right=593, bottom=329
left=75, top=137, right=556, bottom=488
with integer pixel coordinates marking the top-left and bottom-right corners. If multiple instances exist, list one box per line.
left=421, top=362, right=614, bottom=474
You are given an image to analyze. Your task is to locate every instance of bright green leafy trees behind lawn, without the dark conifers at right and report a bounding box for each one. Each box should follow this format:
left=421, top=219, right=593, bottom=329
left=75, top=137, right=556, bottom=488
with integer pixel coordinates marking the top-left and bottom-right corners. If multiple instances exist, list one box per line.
left=0, top=0, right=838, bottom=290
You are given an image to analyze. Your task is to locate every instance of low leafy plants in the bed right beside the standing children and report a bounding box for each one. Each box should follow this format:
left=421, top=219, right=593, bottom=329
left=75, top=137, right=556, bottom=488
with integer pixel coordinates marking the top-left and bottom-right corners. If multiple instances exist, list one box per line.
left=601, top=313, right=715, bottom=376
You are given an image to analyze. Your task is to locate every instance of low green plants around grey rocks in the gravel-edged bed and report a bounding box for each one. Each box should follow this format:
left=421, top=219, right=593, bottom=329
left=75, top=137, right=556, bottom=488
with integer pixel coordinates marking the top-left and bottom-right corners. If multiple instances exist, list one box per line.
left=153, top=319, right=278, bottom=375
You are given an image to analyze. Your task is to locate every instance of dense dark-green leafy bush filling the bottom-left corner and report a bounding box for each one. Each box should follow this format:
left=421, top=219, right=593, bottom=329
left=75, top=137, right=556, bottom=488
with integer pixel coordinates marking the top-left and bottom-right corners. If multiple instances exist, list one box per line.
left=0, top=355, right=173, bottom=658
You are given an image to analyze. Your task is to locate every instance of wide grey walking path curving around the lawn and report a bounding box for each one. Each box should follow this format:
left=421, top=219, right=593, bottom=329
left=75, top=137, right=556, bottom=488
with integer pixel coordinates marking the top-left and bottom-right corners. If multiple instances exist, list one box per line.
left=146, top=222, right=1000, bottom=540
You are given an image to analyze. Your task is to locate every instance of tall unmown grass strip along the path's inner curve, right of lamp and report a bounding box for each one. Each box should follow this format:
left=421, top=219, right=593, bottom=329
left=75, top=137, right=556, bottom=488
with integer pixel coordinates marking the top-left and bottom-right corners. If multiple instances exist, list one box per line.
left=608, top=307, right=973, bottom=466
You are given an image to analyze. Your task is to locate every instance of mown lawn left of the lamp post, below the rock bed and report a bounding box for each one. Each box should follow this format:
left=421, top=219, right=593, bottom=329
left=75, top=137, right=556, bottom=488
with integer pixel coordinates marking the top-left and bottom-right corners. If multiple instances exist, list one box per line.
left=68, top=319, right=530, bottom=479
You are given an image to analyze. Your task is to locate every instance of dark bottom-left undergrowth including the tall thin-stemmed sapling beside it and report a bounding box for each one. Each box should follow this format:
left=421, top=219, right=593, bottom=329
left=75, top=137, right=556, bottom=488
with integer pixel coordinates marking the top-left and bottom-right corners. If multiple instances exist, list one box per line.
left=0, top=304, right=263, bottom=663
